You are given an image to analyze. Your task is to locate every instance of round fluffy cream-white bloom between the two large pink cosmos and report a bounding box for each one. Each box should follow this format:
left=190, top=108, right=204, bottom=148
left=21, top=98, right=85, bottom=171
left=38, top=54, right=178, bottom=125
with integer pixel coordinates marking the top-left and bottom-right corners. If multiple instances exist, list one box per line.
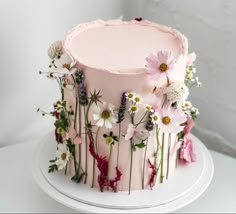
left=167, top=82, right=189, bottom=103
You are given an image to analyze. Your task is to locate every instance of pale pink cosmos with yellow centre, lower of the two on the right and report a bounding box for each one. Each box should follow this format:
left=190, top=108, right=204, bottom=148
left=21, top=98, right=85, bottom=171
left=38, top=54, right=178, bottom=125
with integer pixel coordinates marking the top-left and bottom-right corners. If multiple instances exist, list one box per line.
left=158, top=107, right=186, bottom=134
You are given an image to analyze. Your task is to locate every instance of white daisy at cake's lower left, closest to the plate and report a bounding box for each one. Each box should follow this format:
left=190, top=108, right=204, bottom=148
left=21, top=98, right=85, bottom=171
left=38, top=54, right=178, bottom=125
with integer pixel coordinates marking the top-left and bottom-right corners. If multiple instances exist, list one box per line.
left=55, top=144, right=71, bottom=170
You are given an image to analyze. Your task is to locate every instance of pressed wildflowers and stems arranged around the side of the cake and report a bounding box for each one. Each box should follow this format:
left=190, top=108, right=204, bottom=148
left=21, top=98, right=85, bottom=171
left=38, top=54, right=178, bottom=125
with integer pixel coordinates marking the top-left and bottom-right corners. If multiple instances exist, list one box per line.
left=38, top=37, right=201, bottom=193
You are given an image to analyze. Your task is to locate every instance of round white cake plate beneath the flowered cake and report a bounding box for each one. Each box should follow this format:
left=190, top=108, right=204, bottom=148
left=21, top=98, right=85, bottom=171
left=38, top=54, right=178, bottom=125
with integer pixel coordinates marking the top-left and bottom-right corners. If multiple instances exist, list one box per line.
left=33, top=133, right=214, bottom=213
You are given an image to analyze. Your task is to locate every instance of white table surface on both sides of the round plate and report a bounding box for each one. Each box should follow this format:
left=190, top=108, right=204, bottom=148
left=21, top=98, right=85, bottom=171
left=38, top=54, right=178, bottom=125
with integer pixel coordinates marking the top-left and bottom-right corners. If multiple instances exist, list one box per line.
left=0, top=142, right=236, bottom=213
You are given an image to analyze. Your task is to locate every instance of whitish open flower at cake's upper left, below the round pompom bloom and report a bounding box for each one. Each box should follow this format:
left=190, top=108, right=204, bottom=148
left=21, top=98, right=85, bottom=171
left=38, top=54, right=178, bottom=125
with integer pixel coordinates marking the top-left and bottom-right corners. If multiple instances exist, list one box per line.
left=52, top=53, right=77, bottom=77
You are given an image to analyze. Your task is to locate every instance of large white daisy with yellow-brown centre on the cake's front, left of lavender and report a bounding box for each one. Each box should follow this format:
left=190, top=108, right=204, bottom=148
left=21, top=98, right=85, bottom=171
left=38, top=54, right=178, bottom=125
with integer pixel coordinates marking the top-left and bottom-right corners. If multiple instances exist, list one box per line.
left=93, top=105, right=117, bottom=129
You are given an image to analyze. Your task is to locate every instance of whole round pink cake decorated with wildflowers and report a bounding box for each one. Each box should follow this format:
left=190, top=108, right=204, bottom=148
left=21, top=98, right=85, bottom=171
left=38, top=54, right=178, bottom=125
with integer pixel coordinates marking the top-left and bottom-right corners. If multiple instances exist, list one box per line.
left=39, top=19, right=199, bottom=195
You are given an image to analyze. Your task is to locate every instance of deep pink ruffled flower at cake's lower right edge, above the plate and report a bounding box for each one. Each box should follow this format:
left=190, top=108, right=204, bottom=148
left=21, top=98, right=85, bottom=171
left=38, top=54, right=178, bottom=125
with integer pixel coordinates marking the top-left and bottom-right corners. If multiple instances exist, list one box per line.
left=180, top=137, right=196, bottom=163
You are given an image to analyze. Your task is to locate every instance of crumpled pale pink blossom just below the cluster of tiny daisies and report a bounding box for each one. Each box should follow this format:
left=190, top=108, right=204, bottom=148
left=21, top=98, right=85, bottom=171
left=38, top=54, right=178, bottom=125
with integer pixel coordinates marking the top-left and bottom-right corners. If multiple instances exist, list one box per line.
left=125, top=124, right=149, bottom=144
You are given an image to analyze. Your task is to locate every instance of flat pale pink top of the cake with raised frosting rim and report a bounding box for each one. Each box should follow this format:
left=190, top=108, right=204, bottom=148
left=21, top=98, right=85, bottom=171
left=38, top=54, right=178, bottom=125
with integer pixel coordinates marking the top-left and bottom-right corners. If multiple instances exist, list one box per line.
left=64, top=20, right=188, bottom=73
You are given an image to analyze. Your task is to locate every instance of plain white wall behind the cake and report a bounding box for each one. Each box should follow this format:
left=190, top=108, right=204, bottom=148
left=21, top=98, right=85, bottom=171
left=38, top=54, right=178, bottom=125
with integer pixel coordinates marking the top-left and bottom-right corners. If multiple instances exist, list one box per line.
left=0, top=0, right=236, bottom=156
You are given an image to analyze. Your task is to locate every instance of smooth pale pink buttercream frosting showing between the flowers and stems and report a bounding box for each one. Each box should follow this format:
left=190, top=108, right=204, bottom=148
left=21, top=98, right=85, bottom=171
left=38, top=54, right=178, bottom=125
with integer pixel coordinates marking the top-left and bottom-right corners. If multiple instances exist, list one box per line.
left=64, top=20, right=188, bottom=191
